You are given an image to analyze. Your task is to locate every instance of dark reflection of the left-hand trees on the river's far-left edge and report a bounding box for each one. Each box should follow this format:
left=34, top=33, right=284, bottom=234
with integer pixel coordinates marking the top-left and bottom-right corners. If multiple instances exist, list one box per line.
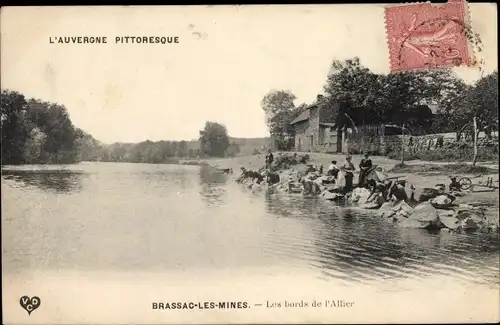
left=2, top=170, right=85, bottom=194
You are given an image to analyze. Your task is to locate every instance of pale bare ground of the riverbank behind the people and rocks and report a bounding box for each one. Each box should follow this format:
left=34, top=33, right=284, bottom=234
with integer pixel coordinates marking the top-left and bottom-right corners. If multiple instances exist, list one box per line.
left=205, top=153, right=499, bottom=232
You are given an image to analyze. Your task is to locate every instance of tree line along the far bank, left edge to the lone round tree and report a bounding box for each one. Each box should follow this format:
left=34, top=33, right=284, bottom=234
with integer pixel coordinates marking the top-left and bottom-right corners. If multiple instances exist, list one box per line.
left=0, top=90, right=240, bottom=165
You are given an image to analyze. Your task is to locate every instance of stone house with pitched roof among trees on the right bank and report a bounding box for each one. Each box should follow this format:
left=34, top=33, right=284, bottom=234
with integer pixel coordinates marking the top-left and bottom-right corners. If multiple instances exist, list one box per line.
left=290, top=95, right=347, bottom=153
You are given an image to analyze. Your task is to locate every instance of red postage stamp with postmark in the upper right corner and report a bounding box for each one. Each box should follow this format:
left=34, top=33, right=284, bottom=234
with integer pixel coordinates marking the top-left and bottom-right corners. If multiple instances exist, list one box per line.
left=385, top=0, right=472, bottom=72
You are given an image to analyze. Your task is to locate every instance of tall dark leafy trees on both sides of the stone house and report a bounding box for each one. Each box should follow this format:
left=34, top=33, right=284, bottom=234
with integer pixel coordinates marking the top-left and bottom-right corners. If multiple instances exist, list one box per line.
left=261, top=57, right=498, bottom=150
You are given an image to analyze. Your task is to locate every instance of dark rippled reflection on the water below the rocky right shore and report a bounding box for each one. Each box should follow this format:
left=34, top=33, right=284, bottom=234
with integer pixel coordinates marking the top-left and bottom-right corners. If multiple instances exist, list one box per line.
left=266, top=195, right=499, bottom=284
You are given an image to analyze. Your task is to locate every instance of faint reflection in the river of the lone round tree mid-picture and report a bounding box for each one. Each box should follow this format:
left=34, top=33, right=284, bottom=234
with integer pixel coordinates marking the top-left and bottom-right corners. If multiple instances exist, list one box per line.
left=199, top=166, right=229, bottom=206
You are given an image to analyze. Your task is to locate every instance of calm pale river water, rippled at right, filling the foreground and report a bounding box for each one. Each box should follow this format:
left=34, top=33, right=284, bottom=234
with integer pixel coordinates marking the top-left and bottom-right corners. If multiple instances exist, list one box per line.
left=2, top=163, right=500, bottom=322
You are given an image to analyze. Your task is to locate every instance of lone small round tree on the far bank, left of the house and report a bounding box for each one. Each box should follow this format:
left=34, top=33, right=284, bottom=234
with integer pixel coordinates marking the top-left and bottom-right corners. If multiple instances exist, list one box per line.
left=200, top=122, right=229, bottom=157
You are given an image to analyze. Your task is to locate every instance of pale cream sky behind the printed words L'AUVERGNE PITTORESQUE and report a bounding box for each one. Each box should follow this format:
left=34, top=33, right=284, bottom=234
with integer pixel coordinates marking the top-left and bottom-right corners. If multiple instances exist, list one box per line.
left=0, top=4, right=498, bottom=143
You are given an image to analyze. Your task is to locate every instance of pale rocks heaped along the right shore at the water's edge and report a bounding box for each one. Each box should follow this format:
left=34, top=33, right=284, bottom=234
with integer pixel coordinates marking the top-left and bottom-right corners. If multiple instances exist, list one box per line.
left=236, top=155, right=499, bottom=233
